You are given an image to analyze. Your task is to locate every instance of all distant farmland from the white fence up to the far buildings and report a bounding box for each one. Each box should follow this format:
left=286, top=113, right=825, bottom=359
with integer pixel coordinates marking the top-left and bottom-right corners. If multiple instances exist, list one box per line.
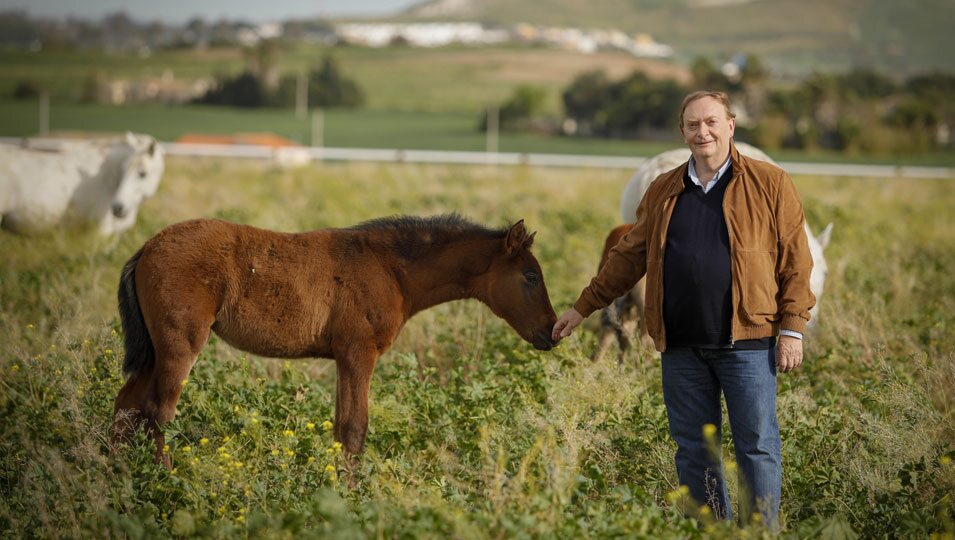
left=0, top=45, right=955, bottom=166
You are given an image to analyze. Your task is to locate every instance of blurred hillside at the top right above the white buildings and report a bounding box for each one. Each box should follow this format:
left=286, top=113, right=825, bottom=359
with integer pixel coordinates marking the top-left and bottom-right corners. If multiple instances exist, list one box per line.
left=399, top=0, right=955, bottom=75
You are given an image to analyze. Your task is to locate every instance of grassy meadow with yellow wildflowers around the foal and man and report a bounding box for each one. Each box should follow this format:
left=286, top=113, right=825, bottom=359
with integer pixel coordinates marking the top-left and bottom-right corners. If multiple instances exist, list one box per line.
left=0, top=158, right=955, bottom=538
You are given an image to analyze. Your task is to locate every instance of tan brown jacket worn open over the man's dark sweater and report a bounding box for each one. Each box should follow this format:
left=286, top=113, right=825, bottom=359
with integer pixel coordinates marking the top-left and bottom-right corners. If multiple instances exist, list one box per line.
left=574, top=146, right=816, bottom=351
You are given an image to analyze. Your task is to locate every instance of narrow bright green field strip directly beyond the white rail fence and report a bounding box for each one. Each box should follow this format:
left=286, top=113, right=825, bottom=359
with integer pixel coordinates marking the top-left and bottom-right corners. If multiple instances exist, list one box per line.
left=0, top=101, right=955, bottom=167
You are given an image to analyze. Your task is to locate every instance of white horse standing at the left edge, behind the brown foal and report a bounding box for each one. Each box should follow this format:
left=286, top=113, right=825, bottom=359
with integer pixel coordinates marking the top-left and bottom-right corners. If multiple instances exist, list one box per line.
left=0, top=133, right=164, bottom=235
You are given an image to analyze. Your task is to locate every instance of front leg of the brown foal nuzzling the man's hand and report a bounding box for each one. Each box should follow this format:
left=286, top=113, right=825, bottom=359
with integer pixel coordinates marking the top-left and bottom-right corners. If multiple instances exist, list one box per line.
left=334, top=347, right=378, bottom=454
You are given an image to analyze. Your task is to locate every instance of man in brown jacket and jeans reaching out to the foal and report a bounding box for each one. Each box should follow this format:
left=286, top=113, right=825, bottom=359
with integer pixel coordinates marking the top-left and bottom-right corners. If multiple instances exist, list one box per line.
left=553, top=92, right=815, bottom=527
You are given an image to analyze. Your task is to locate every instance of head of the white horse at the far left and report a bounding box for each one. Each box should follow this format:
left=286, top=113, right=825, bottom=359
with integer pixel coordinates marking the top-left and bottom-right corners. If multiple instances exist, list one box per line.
left=110, top=132, right=164, bottom=228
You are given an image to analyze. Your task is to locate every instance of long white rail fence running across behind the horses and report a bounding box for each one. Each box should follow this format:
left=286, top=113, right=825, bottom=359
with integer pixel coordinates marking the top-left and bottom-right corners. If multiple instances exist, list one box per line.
left=0, top=137, right=955, bottom=179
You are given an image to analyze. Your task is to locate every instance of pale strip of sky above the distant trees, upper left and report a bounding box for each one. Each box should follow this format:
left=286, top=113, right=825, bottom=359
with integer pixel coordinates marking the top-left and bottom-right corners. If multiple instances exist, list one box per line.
left=0, top=0, right=418, bottom=23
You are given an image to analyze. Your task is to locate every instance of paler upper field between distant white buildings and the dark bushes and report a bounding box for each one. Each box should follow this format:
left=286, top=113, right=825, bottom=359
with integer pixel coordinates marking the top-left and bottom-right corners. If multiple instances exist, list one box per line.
left=0, top=45, right=689, bottom=114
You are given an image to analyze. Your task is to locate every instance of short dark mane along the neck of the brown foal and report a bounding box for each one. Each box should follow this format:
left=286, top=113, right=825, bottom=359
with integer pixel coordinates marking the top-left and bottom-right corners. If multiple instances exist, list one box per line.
left=349, top=214, right=509, bottom=260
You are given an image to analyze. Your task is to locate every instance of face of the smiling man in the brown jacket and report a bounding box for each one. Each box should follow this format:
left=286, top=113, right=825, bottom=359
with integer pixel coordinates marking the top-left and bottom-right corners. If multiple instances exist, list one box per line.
left=680, top=97, right=736, bottom=162
